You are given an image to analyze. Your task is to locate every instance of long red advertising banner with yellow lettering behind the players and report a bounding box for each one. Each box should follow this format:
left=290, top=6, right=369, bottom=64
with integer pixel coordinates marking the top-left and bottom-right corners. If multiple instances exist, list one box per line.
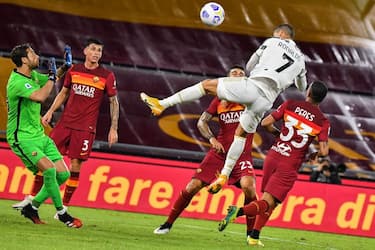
left=0, top=143, right=375, bottom=237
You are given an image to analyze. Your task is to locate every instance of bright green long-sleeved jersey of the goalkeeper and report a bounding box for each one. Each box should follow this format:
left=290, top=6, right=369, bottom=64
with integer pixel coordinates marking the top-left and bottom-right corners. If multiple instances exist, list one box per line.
left=7, top=70, right=48, bottom=144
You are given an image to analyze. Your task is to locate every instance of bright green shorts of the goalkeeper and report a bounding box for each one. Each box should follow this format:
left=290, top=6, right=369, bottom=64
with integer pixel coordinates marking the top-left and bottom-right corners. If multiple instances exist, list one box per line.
left=10, top=136, right=62, bottom=174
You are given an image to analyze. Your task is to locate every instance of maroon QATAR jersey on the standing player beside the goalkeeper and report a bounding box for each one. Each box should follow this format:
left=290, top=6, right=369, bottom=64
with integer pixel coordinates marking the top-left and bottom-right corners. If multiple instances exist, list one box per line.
left=60, top=64, right=117, bottom=132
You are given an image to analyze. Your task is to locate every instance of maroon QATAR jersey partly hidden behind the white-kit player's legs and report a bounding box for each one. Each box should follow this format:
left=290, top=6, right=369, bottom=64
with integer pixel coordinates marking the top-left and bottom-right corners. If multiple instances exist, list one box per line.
left=206, top=97, right=253, bottom=154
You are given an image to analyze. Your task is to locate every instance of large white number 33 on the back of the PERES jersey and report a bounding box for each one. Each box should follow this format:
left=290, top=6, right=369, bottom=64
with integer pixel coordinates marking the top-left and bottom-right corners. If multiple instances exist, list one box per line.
left=280, top=115, right=313, bottom=148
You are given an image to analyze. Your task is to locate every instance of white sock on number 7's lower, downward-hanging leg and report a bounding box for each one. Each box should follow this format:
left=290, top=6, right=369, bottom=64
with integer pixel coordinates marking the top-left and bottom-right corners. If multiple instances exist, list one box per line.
left=221, top=136, right=246, bottom=177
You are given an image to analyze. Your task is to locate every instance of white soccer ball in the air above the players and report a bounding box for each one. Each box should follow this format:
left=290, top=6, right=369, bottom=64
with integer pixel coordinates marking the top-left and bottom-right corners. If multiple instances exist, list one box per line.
left=200, top=2, right=225, bottom=26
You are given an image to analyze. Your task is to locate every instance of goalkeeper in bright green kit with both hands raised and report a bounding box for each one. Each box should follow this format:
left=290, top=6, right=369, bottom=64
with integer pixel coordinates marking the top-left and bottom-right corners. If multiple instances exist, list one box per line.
left=7, top=44, right=82, bottom=228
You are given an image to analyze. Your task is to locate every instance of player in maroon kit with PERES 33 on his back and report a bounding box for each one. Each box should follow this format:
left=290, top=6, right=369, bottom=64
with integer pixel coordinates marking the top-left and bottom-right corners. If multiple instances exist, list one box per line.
left=219, top=81, right=330, bottom=245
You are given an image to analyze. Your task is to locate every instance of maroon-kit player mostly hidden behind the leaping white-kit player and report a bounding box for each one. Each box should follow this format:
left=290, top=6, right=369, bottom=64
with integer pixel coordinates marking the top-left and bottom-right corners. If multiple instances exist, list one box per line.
left=154, top=65, right=256, bottom=243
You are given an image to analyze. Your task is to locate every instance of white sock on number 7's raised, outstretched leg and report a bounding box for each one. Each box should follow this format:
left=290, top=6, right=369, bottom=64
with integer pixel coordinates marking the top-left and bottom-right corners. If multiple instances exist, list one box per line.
left=159, top=82, right=206, bottom=108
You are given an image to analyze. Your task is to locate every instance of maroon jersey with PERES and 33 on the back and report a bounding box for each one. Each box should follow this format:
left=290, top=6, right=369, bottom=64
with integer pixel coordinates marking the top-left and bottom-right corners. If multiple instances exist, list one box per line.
left=268, top=100, right=330, bottom=167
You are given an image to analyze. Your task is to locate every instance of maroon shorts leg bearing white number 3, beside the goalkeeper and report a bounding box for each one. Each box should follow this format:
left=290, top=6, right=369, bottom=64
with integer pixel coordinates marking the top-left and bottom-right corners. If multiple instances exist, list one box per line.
left=68, top=130, right=95, bottom=161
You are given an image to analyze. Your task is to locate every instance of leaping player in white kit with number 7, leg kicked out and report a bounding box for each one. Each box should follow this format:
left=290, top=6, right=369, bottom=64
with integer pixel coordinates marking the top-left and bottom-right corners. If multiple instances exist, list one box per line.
left=140, top=24, right=307, bottom=197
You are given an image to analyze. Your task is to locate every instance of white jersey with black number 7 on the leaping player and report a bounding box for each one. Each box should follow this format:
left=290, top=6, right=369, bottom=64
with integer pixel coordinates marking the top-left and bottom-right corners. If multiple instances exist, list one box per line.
left=250, top=37, right=306, bottom=92
